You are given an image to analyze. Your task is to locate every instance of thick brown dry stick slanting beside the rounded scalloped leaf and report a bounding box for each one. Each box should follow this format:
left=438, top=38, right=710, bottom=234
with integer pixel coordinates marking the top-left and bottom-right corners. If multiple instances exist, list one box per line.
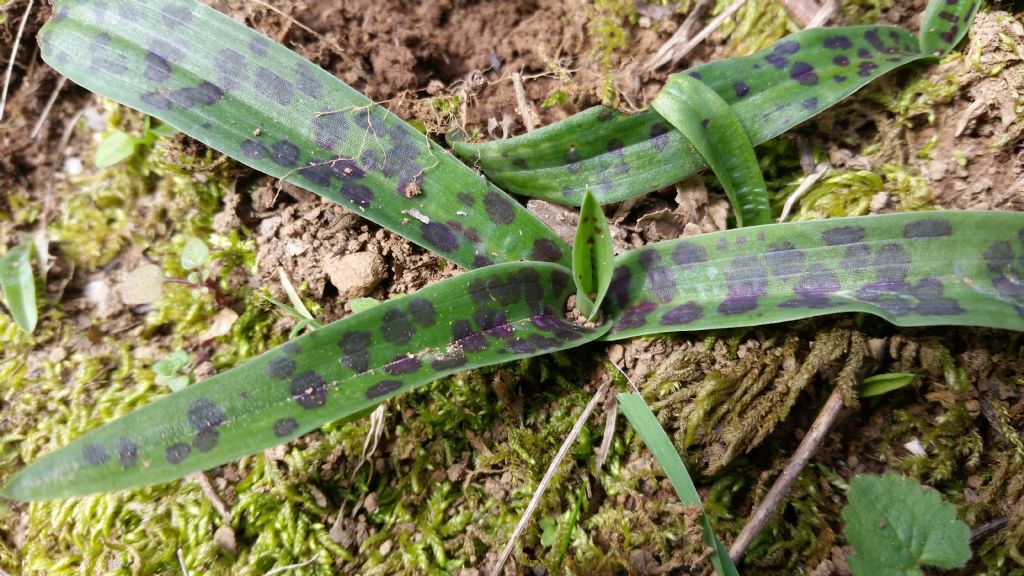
left=729, top=386, right=843, bottom=563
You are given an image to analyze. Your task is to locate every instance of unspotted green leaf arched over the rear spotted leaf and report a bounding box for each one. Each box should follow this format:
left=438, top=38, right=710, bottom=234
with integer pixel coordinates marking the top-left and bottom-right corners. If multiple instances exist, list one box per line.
left=651, top=74, right=771, bottom=228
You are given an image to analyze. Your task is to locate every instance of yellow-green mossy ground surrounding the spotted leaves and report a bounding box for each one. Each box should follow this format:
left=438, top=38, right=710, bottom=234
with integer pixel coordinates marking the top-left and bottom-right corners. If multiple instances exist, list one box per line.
left=0, top=1, right=1024, bottom=575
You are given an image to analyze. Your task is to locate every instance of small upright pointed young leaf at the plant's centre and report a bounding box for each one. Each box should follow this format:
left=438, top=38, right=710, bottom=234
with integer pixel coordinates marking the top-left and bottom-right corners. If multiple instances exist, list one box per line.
left=572, top=193, right=615, bottom=320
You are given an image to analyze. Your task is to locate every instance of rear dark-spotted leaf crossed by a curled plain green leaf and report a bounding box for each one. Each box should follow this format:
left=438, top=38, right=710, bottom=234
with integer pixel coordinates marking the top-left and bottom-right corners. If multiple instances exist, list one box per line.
left=450, top=0, right=980, bottom=206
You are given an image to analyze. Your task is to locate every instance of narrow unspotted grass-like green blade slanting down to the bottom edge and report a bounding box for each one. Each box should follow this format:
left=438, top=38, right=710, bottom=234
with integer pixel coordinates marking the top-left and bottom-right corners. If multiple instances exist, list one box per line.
left=616, top=393, right=739, bottom=576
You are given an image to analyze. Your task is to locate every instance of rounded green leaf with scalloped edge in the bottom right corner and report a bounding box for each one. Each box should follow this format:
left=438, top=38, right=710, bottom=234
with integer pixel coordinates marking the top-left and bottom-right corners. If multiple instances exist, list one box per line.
left=843, top=472, right=971, bottom=576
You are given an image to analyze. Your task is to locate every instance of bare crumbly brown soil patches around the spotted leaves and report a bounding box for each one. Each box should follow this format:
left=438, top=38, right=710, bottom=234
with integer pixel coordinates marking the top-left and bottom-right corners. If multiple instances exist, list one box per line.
left=0, top=0, right=1024, bottom=573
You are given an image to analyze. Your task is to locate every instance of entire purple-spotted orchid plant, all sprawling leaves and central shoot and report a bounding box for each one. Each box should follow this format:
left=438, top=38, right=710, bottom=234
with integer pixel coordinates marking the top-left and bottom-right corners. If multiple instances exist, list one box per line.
left=3, top=10, right=1024, bottom=576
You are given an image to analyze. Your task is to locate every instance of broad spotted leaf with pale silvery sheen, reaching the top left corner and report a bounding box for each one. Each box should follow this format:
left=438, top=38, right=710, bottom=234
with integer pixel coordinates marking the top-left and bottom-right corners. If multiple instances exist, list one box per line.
left=39, top=0, right=569, bottom=268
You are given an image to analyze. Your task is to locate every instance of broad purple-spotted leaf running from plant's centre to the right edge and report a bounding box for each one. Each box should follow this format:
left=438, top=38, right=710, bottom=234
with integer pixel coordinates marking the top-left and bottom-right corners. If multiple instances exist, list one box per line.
left=604, top=211, right=1024, bottom=339
